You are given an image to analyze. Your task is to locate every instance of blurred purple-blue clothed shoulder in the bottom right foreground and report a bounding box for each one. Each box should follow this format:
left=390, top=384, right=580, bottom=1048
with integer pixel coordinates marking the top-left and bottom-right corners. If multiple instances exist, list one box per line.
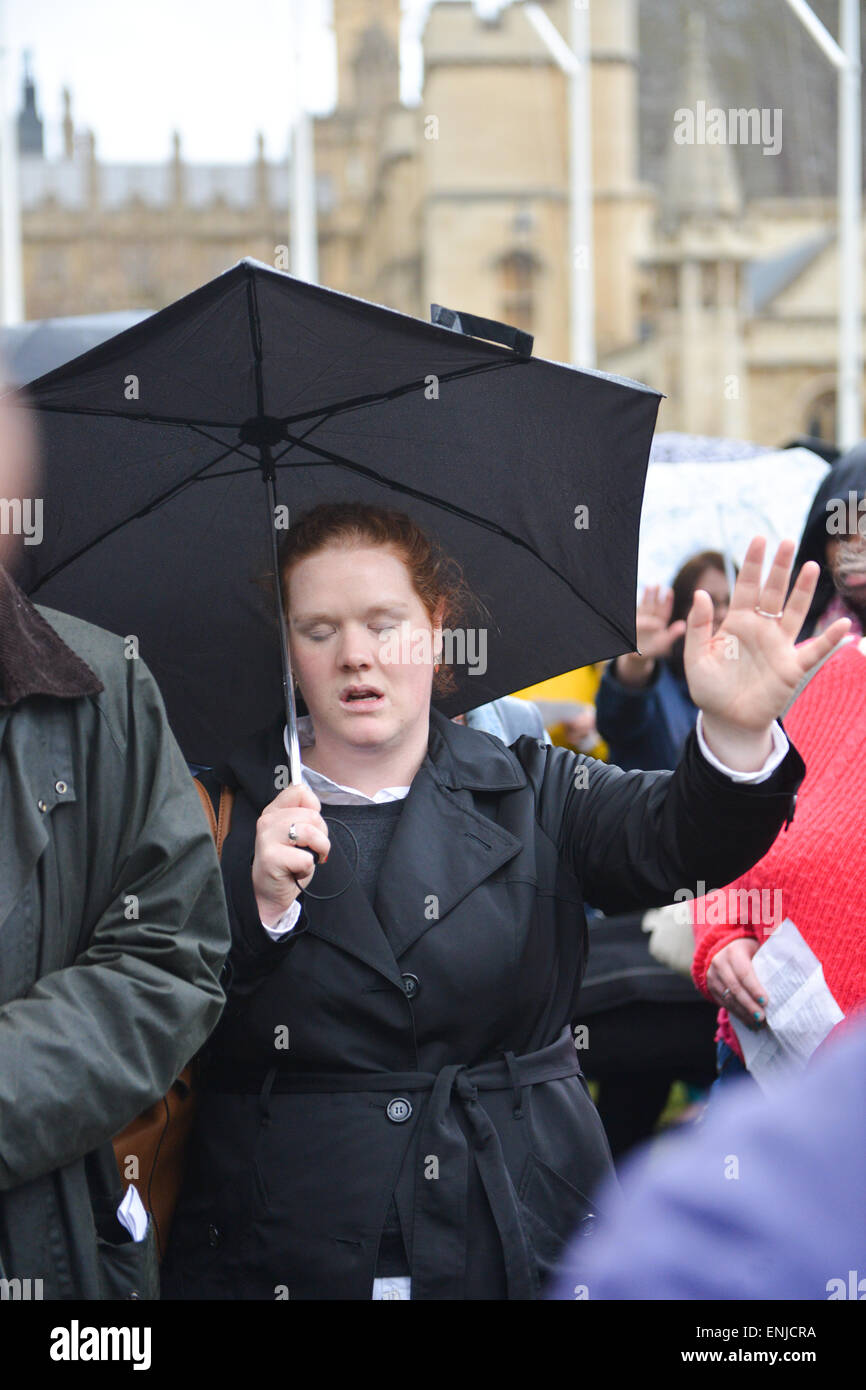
left=550, top=1022, right=866, bottom=1301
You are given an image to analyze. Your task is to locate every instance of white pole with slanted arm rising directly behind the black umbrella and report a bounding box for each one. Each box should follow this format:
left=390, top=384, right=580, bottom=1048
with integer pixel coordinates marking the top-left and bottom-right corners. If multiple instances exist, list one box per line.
left=525, top=0, right=595, bottom=367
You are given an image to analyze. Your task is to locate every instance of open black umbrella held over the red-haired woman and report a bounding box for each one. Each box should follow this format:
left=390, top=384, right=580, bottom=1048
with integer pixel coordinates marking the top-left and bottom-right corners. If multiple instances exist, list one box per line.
left=10, top=260, right=660, bottom=771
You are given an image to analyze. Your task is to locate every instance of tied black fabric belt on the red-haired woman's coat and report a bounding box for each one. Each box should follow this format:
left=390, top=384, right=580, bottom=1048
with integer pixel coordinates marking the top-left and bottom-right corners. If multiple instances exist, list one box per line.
left=204, top=1027, right=580, bottom=1300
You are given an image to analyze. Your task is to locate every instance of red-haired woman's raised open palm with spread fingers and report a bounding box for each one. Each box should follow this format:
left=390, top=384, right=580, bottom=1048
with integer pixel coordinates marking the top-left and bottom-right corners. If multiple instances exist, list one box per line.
left=683, top=537, right=851, bottom=746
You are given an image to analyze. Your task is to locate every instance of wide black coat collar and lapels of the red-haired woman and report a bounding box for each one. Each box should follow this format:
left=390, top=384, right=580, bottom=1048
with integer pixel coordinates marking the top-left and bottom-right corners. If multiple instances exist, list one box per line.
left=215, top=709, right=527, bottom=987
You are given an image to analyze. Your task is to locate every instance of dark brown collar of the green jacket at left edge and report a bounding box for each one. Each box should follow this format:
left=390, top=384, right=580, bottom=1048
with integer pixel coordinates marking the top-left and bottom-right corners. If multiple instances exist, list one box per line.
left=0, top=564, right=104, bottom=709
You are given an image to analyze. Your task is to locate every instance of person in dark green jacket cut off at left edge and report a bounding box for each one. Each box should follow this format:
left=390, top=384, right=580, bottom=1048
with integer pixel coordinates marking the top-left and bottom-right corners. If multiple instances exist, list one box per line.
left=0, top=372, right=229, bottom=1300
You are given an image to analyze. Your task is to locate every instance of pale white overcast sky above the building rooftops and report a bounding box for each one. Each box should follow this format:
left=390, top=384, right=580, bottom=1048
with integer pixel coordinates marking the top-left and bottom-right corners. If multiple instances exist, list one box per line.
left=0, top=0, right=500, bottom=163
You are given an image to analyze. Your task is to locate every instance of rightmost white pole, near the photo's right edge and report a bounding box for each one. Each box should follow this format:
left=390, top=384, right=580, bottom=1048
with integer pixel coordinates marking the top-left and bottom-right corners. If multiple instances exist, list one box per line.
left=837, top=0, right=863, bottom=450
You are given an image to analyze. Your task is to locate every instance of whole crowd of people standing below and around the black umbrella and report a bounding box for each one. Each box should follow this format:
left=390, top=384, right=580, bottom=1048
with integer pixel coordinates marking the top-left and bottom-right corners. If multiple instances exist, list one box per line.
left=0, top=361, right=866, bottom=1300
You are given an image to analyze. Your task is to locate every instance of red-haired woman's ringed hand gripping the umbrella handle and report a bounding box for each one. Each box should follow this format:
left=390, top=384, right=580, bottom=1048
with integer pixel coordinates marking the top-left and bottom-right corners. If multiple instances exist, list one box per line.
left=253, top=783, right=331, bottom=927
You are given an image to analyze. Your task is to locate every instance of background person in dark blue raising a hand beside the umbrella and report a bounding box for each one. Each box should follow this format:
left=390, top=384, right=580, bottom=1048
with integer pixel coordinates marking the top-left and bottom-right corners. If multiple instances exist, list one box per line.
left=596, top=550, right=731, bottom=769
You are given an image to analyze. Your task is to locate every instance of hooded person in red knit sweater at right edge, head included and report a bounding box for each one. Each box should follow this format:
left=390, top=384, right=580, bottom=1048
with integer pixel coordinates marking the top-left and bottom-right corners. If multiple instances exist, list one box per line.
left=691, top=461, right=866, bottom=1083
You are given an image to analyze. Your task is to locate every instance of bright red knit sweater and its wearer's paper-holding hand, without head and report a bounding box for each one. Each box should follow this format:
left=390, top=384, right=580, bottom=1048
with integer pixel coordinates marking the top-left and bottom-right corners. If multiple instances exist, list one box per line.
left=691, top=638, right=866, bottom=1076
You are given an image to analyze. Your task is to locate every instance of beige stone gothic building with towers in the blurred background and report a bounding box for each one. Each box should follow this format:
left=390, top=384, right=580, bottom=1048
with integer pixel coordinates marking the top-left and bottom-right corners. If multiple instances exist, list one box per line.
left=18, top=0, right=866, bottom=443
